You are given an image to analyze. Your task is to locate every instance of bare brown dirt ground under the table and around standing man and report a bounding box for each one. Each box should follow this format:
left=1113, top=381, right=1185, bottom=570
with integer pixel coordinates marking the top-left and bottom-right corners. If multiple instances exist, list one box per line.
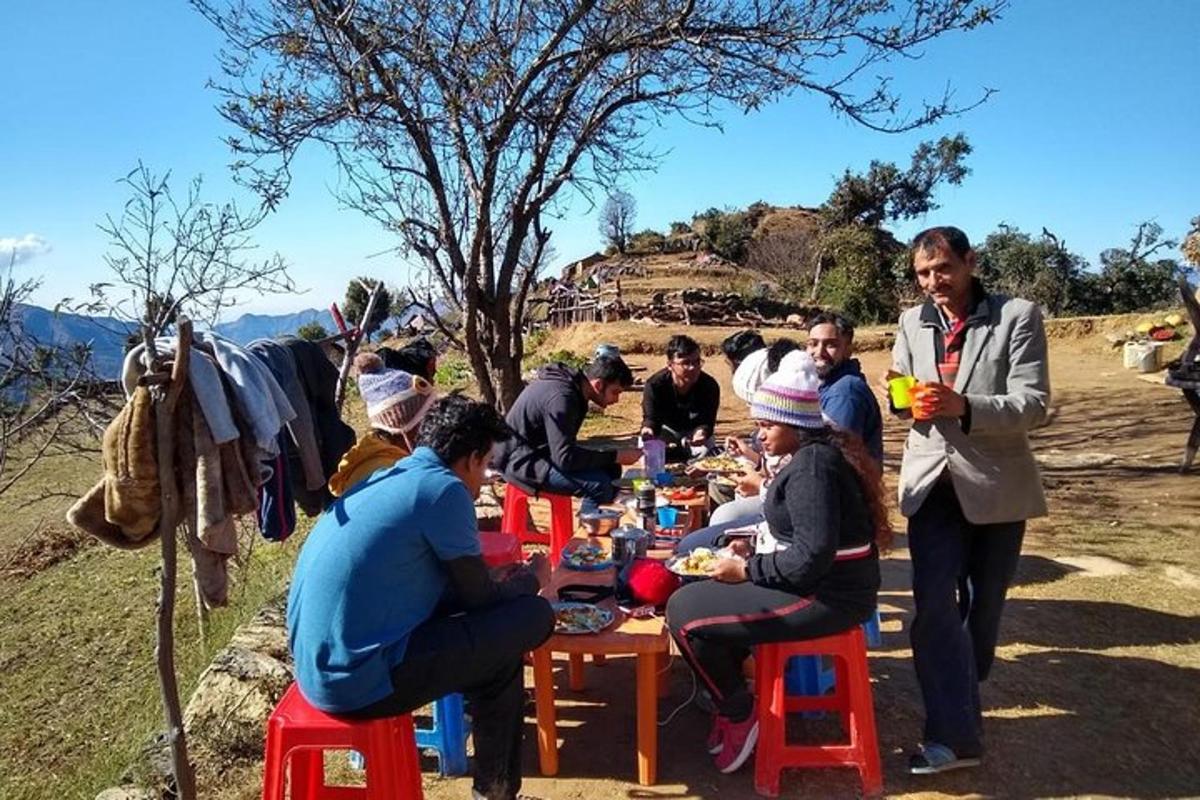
left=415, top=335, right=1200, bottom=800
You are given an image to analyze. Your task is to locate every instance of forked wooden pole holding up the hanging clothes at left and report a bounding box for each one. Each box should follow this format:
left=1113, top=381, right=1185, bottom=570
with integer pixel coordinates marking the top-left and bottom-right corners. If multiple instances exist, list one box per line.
left=146, top=319, right=197, bottom=800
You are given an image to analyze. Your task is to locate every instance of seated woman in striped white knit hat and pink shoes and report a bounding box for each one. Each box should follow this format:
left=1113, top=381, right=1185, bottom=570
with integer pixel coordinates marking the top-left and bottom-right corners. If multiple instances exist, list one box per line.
left=667, top=359, right=892, bottom=772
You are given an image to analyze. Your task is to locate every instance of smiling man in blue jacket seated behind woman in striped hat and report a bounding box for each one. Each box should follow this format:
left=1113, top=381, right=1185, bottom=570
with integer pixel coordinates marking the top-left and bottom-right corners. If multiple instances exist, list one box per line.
left=808, top=311, right=883, bottom=463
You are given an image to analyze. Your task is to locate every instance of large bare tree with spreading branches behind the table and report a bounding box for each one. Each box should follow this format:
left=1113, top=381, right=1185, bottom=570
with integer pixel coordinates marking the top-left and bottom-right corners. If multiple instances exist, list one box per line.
left=192, top=0, right=1004, bottom=407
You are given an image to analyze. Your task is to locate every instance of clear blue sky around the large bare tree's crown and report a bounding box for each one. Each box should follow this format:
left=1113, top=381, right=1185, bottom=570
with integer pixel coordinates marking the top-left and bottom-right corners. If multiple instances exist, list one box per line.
left=0, top=0, right=1200, bottom=313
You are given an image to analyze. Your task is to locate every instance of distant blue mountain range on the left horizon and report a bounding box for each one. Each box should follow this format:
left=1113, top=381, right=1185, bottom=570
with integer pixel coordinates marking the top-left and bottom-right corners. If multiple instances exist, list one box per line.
left=14, top=305, right=334, bottom=379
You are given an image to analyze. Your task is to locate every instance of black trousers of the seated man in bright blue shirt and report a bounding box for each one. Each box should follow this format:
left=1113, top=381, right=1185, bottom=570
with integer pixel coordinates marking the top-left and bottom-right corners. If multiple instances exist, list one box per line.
left=346, top=596, right=554, bottom=800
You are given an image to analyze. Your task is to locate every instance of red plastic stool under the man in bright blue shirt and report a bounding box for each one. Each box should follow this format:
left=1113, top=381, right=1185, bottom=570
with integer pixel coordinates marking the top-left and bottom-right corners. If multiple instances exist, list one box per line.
left=263, top=684, right=424, bottom=800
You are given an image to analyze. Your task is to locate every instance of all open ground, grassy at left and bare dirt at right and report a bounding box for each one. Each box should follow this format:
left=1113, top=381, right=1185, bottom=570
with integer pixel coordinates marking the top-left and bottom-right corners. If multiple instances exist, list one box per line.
left=0, top=320, right=1200, bottom=800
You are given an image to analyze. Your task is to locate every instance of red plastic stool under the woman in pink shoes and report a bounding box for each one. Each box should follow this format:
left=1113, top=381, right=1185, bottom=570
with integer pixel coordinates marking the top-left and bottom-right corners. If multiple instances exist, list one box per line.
left=754, top=625, right=883, bottom=798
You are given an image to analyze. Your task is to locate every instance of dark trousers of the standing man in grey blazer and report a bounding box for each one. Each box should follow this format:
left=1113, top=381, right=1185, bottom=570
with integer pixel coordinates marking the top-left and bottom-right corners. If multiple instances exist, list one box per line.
left=908, top=481, right=1025, bottom=756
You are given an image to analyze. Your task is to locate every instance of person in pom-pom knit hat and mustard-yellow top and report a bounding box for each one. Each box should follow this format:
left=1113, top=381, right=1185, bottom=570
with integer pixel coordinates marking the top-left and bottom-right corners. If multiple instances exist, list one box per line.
left=329, top=353, right=437, bottom=497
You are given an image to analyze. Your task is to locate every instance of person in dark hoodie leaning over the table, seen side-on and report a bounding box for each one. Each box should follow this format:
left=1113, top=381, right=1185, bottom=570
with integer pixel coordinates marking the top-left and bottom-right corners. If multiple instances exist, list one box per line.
left=492, top=356, right=642, bottom=511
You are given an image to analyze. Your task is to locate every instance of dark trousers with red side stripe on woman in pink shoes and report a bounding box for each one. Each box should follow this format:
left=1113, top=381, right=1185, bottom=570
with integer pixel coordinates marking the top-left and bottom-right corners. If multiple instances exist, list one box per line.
left=667, top=581, right=875, bottom=722
